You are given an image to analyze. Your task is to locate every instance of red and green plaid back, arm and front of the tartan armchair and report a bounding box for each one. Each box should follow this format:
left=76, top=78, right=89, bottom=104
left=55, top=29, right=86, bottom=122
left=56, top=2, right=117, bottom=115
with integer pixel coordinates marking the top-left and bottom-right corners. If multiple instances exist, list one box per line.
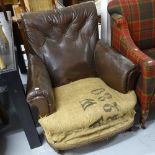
left=108, top=0, right=155, bottom=119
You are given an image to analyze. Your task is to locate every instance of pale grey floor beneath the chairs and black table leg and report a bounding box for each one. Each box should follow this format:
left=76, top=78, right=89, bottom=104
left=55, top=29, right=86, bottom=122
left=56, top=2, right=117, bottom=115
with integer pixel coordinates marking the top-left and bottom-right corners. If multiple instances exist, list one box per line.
left=0, top=73, right=155, bottom=155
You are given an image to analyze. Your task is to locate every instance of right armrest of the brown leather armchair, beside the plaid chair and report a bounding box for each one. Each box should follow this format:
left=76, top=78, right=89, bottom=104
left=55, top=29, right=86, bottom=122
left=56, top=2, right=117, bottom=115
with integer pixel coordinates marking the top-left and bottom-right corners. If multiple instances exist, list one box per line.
left=95, top=41, right=139, bottom=93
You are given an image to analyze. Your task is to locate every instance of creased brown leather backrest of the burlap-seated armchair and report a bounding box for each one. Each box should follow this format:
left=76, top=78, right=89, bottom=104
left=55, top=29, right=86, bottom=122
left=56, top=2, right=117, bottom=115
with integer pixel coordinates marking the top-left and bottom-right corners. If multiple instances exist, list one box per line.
left=23, top=2, right=98, bottom=86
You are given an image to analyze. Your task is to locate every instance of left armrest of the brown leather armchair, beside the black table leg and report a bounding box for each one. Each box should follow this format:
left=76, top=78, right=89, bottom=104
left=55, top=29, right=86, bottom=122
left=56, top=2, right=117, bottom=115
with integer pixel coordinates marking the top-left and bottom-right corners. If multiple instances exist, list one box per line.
left=27, top=54, right=55, bottom=116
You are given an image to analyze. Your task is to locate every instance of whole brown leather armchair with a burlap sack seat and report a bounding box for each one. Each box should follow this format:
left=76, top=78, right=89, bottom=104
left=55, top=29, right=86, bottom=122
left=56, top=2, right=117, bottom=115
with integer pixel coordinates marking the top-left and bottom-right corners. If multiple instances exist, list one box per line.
left=22, top=2, right=138, bottom=150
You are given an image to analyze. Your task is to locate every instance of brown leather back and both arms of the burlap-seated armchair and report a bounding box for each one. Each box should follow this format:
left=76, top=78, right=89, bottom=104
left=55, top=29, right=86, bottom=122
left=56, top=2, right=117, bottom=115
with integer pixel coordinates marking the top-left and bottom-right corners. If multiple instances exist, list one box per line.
left=22, top=2, right=136, bottom=115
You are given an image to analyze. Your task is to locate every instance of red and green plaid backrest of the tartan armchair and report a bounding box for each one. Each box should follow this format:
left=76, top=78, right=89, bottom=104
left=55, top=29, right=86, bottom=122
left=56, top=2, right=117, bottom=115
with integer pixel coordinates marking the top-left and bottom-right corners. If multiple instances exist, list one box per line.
left=108, top=0, right=155, bottom=49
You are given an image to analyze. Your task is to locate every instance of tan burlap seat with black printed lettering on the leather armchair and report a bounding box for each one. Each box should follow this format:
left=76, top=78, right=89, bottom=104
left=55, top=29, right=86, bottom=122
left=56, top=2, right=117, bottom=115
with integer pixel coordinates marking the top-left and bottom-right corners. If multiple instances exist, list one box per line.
left=39, top=78, right=136, bottom=150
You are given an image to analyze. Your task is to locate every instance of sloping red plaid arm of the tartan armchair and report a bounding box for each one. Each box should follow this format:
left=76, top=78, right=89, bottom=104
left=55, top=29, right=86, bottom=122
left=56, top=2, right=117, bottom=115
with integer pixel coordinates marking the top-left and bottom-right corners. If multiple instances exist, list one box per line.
left=111, top=14, right=152, bottom=64
